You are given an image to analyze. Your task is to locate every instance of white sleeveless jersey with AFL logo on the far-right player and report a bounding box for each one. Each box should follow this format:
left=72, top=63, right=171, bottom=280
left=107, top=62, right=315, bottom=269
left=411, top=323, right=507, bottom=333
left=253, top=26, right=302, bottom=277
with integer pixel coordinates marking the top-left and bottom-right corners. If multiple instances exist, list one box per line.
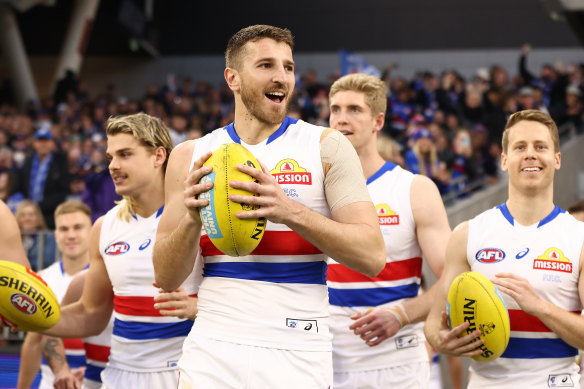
left=467, top=204, right=584, bottom=388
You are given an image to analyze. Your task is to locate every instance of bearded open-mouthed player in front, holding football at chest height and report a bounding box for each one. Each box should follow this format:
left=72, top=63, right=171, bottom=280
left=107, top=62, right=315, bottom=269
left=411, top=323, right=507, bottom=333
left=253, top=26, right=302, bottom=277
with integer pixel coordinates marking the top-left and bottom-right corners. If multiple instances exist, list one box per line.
left=154, top=25, right=385, bottom=389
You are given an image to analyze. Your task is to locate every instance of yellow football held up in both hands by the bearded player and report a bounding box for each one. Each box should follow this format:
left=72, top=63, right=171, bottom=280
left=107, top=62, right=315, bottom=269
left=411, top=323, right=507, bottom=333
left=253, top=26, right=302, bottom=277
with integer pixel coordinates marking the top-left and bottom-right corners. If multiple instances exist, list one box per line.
left=199, top=143, right=266, bottom=257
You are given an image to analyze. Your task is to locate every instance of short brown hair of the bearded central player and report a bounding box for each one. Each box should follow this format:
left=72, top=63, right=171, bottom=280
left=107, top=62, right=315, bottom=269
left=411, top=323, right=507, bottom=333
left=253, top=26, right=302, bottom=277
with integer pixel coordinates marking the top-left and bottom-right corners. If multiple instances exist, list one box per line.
left=225, top=24, right=294, bottom=70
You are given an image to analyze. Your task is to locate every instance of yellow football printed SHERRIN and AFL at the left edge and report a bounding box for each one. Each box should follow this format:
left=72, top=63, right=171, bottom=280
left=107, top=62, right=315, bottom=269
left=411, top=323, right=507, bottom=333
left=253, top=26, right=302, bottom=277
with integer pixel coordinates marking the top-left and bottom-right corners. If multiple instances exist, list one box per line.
left=0, top=261, right=61, bottom=331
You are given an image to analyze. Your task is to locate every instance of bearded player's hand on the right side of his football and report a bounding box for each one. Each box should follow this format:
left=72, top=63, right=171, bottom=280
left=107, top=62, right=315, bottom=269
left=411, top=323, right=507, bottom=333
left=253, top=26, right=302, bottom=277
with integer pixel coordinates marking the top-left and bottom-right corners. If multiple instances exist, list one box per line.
left=229, top=162, right=298, bottom=223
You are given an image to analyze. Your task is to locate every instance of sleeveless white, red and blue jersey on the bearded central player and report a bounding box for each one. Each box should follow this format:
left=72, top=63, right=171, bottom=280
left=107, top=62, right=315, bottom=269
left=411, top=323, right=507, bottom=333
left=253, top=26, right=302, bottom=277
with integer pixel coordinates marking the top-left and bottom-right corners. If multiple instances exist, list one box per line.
left=191, top=117, right=331, bottom=351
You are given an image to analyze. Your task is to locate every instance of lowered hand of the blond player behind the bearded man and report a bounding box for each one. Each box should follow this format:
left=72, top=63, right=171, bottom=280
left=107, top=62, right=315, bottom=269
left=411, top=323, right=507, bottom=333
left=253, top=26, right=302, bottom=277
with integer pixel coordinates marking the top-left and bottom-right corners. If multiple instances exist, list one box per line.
left=349, top=308, right=400, bottom=346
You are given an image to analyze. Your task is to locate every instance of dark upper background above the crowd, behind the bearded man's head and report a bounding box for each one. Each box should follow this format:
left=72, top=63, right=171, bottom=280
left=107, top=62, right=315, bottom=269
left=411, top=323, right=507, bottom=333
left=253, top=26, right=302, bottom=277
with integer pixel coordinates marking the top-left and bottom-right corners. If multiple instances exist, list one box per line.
left=13, top=0, right=580, bottom=56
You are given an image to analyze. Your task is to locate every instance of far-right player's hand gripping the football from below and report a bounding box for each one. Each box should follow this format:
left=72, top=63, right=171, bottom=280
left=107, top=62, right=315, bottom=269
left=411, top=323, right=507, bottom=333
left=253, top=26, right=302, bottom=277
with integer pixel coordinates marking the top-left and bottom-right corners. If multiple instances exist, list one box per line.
left=433, top=311, right=484, bottom=357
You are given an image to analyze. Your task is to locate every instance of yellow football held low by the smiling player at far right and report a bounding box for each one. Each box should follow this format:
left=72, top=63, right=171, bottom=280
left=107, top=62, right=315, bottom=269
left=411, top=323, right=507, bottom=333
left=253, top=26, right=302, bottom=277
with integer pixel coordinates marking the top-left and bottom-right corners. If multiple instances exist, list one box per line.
left=447, top=272, right=510, bottom=362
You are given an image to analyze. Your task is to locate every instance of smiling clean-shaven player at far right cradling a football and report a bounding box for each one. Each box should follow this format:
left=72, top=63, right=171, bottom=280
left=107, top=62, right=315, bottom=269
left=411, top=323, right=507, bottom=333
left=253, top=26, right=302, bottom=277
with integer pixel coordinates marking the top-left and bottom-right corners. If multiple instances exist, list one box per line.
left=425, top=110, right=584, bottom=388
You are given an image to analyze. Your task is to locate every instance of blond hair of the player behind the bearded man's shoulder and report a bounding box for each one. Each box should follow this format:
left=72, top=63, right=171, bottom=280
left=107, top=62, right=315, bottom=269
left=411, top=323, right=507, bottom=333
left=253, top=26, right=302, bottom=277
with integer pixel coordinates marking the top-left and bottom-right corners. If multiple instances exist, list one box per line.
left=329, top=73, right=387, bottom=116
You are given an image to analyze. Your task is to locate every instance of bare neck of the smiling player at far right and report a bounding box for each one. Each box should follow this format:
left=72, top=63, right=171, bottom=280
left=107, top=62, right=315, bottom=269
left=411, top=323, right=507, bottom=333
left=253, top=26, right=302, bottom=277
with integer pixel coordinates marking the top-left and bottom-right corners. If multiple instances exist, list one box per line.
left=507, top=188, right=555, bottom=226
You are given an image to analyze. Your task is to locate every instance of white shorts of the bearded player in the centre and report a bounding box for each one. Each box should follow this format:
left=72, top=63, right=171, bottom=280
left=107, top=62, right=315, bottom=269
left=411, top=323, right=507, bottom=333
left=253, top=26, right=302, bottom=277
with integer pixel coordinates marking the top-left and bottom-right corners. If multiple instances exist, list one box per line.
left=178, top=334, right=333, bottom=389
